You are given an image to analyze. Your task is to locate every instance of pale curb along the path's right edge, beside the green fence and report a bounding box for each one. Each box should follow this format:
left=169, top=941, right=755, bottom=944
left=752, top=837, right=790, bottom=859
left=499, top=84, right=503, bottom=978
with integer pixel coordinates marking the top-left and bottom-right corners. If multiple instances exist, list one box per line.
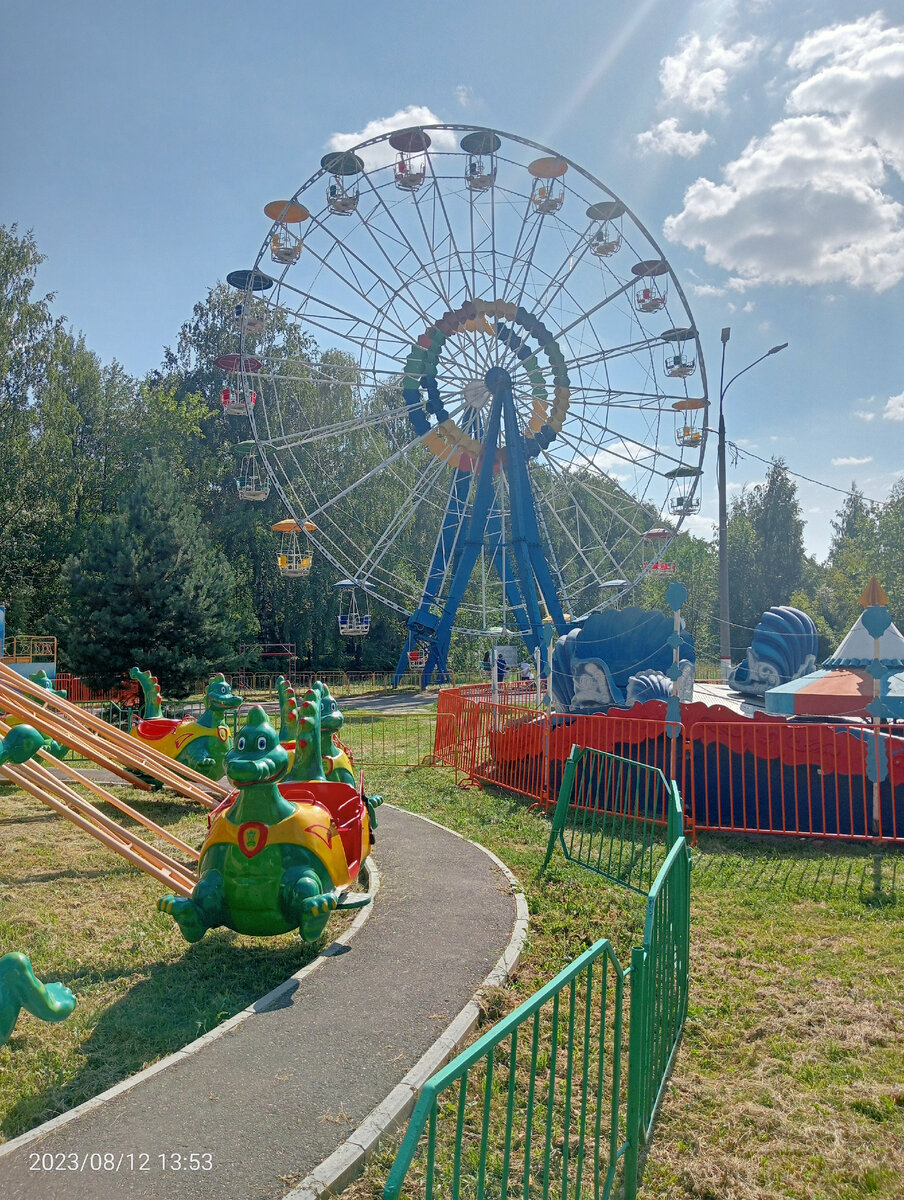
left=282, top=805, right=529, bottom=1200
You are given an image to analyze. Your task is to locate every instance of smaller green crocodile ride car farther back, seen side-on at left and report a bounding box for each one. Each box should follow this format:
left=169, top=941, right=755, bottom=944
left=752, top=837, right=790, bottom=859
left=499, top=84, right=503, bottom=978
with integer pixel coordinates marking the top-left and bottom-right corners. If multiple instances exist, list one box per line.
left=128, top=667, right=244, bottom=780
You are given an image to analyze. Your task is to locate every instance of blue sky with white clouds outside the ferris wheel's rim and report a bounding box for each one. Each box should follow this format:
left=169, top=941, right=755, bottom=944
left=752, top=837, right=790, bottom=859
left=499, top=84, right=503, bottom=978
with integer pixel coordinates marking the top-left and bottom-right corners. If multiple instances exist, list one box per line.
left=0, top=0, right=904, bottom=556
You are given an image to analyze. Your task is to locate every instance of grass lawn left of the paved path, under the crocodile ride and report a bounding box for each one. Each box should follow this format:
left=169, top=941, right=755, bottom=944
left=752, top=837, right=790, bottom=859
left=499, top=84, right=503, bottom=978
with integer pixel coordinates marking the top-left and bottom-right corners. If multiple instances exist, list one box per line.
left=0, top=785, right=352, bottom=1141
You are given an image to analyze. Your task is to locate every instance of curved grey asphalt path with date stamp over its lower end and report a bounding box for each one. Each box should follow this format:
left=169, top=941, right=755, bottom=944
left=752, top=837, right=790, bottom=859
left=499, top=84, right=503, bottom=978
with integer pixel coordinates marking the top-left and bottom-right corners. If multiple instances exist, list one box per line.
left=0, top=808, right=515, bottom=1200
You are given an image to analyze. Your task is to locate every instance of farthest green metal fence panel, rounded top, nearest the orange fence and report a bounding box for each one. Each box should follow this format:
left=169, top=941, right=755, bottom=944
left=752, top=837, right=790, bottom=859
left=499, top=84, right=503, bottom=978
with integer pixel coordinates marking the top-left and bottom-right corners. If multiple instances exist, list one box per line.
left=543, top=746, right=683, bottom=895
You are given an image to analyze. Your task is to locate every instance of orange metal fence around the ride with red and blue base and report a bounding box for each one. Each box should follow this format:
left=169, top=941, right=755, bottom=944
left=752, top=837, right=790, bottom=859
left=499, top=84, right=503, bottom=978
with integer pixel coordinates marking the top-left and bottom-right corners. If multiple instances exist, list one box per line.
left=433, top=688, right=904, bottom=844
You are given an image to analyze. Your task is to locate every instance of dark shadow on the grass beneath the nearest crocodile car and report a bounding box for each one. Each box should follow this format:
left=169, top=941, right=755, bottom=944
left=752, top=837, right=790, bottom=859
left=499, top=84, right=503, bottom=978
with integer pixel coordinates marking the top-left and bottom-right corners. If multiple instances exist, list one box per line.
left=0, top=932, right=322, bottom=1138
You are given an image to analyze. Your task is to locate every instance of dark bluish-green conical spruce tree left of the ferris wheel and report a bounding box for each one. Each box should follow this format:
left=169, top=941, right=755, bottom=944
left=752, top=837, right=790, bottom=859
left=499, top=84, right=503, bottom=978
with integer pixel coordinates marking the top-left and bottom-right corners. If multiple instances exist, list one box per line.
left=65, top=460, right=246, bottom=697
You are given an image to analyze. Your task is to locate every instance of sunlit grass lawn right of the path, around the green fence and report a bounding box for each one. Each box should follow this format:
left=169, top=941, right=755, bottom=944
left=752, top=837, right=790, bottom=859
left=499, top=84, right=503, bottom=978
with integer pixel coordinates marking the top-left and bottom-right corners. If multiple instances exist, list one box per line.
left=353, top=769, right=904, bottom=1200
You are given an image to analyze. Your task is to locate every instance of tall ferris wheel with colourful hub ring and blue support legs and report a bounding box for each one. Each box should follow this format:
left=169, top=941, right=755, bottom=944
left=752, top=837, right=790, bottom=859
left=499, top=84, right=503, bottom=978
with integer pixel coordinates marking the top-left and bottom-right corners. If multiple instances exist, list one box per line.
left=228, top=125, right=707, bottom=684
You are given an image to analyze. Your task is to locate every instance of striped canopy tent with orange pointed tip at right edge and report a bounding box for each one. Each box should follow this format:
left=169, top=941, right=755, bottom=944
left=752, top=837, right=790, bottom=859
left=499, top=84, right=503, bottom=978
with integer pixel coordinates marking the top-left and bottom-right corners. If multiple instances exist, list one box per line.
left=766, top=578, right=904, bottom=721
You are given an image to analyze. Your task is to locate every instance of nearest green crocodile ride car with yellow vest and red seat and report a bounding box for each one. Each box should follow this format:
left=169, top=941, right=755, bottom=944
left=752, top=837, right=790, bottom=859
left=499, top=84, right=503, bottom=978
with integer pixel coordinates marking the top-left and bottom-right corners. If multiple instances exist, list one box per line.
left=157, top=707, right=370, bottom=942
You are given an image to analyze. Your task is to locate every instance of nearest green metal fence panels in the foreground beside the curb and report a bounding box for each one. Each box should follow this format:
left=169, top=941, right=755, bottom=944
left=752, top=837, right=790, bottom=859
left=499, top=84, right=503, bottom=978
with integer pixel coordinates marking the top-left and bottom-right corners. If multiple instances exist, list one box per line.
left=383, top=768, right=690, bottom=1200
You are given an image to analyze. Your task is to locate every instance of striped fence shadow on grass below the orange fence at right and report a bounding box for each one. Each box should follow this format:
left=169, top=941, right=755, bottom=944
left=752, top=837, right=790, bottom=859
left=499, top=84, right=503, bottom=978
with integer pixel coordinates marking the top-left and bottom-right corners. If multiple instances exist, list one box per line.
left=694, top=833, right=904, bottom=906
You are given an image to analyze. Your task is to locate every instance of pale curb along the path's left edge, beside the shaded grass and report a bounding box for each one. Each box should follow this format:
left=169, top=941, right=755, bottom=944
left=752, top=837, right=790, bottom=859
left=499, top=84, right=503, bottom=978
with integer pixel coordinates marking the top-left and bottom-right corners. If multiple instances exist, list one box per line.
left=0, top=859, right=379, bottom=1158
